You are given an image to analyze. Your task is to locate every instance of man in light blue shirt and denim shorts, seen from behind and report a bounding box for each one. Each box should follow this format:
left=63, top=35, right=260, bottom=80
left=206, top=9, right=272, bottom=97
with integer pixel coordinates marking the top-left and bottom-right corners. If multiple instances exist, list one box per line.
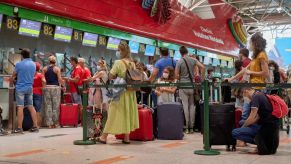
left=12, top=49, right=39, bottom=133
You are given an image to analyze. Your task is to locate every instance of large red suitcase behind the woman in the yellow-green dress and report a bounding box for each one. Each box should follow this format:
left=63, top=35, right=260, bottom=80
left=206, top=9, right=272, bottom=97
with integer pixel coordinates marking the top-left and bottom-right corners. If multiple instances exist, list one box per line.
left=116, top=107, right=153, bottom=141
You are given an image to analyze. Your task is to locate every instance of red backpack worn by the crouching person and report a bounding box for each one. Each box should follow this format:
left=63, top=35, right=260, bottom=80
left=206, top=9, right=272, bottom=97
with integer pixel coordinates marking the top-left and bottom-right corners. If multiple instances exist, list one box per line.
left=266, top=95, right=288, bottom=118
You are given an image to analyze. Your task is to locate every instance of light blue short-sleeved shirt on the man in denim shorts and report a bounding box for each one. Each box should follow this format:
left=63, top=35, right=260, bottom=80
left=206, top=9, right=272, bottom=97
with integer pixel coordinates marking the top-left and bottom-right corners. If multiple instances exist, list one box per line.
left=15, top=58, right=36, bottom=91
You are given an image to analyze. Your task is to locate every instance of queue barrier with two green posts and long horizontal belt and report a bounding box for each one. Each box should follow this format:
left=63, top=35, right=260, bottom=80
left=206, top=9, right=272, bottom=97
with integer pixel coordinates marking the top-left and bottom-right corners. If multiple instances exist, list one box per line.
left=74, top=80, right=291, bottom=155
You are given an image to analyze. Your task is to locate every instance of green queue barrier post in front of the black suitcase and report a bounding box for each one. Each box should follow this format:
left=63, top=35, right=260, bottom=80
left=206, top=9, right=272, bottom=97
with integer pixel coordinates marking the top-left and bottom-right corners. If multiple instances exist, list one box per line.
left=194, top=80, right=220, bottom=155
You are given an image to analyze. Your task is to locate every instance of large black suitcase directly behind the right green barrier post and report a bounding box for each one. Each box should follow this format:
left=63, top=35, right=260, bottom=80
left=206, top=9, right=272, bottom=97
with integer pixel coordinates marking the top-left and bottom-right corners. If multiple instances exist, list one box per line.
left=200, top=103, right=236, bottom=151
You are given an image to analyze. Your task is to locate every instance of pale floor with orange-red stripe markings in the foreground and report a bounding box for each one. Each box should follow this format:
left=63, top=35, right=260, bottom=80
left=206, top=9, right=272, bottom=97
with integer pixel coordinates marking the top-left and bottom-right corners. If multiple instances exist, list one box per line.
left=0, top=128, right=291, bottom=164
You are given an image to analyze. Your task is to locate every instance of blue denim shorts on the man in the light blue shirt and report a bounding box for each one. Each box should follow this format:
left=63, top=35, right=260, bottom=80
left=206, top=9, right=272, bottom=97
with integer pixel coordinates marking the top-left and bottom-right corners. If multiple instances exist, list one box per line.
left=15, top=88, right=33, bottom=107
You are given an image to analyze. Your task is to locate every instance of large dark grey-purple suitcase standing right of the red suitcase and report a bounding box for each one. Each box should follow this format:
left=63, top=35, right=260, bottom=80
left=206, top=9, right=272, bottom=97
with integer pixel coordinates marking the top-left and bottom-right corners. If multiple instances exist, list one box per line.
left=156, top=102, right=184, bottom=140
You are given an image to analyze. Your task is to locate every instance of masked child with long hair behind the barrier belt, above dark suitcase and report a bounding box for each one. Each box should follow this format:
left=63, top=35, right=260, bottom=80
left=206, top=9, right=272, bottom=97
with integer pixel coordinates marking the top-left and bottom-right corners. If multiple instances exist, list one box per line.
left=156, top=67, right=177, bottom=104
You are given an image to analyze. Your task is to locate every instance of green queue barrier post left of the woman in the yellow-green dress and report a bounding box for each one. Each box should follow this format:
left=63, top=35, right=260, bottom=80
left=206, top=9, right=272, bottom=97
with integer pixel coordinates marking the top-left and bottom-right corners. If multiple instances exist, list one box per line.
left=74, top=83, right=96, bottom=145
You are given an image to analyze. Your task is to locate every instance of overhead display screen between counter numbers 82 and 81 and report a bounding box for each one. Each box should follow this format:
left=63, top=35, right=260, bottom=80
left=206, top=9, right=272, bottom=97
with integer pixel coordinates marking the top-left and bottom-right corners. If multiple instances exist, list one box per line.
left=54, top=26, right=73, bottom=42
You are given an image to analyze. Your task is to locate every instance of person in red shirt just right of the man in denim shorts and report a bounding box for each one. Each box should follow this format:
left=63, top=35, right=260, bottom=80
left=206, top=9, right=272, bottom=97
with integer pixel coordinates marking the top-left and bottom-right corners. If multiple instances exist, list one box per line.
left=33, top=62, right=46, bottom=125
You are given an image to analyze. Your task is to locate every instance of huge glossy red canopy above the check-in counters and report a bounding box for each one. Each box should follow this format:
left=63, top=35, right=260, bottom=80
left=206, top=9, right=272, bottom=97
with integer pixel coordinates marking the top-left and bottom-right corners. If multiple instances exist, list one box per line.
left=3, top=0, right=239, bottom=55
